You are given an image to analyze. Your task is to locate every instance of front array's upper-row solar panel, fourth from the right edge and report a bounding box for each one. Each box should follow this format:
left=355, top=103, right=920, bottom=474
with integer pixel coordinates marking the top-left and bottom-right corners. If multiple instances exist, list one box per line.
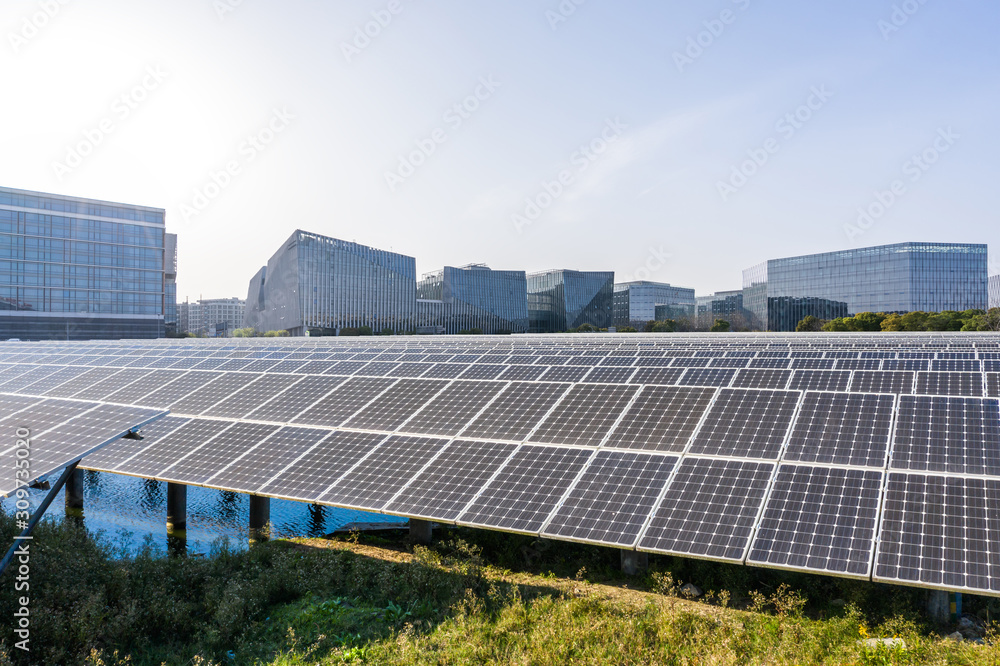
left=604, top=386, right=715, bottom=452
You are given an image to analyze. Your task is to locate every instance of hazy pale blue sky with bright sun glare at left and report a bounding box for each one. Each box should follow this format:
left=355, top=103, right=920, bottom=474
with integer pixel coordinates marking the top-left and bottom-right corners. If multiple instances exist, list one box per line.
left=0, top=0, right=1000, bottom=301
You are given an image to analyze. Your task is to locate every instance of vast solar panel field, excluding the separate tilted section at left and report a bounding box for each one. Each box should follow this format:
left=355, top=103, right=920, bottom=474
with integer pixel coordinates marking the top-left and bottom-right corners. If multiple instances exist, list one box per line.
left=0, top=334, right=1000, bottom=594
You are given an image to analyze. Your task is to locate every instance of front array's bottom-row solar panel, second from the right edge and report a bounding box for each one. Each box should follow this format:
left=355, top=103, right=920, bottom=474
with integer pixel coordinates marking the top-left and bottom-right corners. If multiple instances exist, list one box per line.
left=747, top=465, right=882, bottom=578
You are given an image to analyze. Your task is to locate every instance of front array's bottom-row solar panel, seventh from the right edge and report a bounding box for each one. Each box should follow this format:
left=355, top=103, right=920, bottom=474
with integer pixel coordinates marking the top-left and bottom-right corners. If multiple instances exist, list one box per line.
left=318, top=435, right=448, bottom=511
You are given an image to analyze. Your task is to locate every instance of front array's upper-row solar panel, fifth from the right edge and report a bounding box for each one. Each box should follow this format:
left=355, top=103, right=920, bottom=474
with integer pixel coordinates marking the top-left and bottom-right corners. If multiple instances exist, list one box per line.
left=529, top=384, right=638, bottom=446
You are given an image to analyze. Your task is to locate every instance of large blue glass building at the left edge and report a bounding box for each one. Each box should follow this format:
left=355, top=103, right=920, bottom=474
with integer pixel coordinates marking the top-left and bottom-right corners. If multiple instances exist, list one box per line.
left=0, top=188, right=166, bottom=340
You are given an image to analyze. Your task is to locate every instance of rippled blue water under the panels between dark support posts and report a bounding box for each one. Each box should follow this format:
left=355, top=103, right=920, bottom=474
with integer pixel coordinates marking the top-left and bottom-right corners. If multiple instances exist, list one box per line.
left=0, top=471, right=406, bottom=553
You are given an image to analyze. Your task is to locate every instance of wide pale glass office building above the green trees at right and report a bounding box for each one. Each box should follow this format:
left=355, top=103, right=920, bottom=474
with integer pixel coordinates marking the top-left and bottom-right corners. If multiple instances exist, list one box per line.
left=743, top=243, right=987, bottom=331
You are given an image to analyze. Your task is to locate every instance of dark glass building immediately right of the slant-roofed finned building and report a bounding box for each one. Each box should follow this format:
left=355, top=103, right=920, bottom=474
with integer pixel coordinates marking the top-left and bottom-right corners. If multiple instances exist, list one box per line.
left=417, top=264, right=528, bottom=334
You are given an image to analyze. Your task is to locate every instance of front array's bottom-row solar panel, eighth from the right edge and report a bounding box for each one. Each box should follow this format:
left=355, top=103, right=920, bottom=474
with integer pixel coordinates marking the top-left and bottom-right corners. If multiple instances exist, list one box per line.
left=258, top=431, right=386, bottom=502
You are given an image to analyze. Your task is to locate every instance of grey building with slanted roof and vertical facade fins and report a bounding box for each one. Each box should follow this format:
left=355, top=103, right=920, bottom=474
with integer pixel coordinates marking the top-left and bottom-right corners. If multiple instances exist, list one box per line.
left=244, top=230, right=417, bottom=335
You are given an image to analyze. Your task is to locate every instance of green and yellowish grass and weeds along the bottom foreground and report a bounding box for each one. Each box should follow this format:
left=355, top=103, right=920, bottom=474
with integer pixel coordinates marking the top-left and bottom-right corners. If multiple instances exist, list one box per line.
left=0, top=516, right=1000, bottom=666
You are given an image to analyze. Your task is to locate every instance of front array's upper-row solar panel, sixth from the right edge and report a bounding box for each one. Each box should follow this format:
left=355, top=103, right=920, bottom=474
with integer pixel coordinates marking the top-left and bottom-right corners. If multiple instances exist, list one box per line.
left=461, top=382, right=569, bottom=442
